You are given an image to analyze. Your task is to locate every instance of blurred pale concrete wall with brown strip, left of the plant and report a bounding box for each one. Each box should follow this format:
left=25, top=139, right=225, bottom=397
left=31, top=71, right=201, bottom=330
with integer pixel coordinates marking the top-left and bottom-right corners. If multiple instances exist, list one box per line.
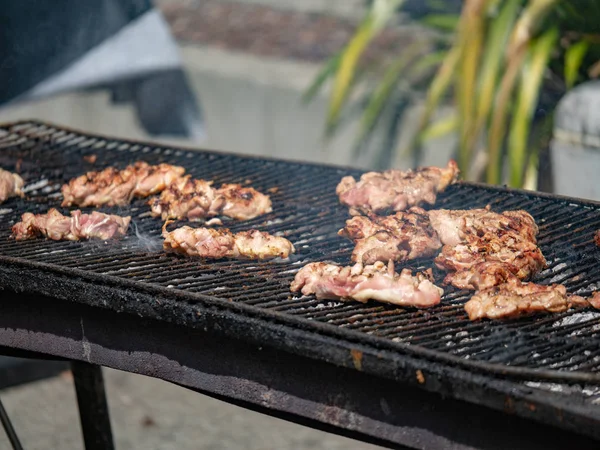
left=0, top=0, right=460, bottom=171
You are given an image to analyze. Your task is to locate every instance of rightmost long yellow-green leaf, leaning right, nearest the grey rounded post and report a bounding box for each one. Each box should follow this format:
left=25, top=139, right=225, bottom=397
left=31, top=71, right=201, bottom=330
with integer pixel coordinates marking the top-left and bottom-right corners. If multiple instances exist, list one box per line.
left=508, top=27, right=558, bottom=187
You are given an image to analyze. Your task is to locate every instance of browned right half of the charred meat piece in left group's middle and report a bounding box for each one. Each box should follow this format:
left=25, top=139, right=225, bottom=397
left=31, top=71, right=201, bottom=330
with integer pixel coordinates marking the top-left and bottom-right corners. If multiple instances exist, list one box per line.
left=218, top=184, right=273, bottom=220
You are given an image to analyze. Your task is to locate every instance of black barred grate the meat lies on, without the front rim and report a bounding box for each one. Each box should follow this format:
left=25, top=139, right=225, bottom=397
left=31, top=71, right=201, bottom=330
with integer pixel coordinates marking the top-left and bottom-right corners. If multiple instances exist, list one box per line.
left=0, top=122, right=600, bottom=401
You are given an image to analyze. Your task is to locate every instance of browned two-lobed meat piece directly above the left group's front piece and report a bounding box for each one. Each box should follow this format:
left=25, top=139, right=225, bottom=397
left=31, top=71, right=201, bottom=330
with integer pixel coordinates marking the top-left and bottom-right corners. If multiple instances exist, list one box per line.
left=149, top=179, right=272, bottom=221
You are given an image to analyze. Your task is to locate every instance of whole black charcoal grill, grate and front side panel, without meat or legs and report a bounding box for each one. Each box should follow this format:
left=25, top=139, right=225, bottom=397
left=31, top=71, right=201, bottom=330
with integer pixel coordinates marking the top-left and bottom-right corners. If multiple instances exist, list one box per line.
left=0, top=123, right=600, bottom=448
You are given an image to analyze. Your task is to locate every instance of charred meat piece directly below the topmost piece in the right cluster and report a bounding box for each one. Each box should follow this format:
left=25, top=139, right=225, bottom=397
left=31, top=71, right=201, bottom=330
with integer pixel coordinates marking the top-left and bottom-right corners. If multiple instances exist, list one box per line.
left=338, top=206, right=442, bottom=264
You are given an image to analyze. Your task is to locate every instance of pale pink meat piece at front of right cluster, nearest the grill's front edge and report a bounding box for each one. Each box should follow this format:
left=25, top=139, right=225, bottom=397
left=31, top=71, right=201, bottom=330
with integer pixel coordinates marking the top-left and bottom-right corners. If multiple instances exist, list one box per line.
left=291, top=262, right=444, bottom=308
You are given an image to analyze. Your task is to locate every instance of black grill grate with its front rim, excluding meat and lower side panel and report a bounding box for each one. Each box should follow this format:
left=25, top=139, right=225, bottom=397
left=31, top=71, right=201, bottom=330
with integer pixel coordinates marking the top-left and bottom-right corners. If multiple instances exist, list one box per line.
left=0, top=122, right=600, bottom=446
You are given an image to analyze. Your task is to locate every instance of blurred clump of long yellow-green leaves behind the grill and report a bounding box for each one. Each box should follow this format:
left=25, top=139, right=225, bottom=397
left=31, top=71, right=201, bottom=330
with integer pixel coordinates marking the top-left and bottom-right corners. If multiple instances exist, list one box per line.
left=305, top=0, right=600, bottom=187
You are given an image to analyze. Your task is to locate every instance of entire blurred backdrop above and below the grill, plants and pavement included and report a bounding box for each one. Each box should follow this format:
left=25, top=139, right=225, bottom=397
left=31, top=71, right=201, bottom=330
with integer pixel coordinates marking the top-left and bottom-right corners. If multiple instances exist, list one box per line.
left=0, top=0, right=600, bottom=449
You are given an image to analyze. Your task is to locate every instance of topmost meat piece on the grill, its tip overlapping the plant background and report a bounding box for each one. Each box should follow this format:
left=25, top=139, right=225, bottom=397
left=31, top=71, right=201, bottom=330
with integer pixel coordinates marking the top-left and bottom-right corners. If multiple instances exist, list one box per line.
left=335, top=160, right=459, bottom=216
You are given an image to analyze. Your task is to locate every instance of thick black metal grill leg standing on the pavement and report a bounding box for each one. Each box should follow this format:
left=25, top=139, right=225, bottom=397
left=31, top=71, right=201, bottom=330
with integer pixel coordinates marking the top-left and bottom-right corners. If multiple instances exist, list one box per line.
left=71, top=361, right=115, bottom=450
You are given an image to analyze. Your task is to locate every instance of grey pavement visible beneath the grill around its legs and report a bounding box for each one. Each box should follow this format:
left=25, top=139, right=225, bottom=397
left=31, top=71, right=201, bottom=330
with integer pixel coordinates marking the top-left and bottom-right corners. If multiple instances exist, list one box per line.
left=0, top=369, right=380, bottom=450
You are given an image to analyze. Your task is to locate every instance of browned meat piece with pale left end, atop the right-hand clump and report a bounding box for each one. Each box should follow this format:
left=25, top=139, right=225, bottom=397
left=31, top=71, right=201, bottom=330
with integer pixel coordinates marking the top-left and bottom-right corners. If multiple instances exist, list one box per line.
left=429, top=207, right=538, bottom=245
